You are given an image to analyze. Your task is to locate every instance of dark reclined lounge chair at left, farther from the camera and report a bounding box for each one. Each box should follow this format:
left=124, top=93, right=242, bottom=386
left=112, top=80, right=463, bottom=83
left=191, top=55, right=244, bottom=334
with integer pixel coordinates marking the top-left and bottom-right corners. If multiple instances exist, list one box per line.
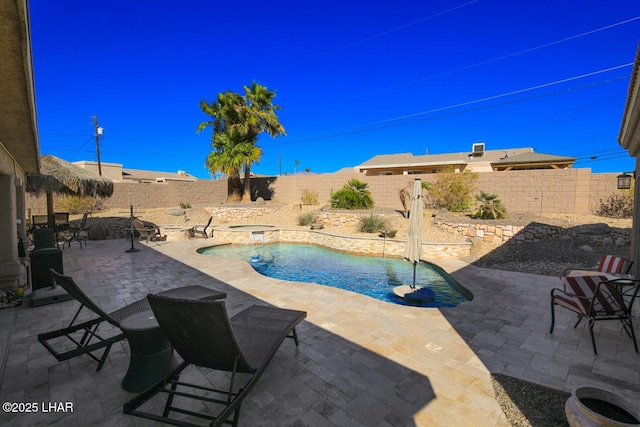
left=38, top=269, right=226, bottom=377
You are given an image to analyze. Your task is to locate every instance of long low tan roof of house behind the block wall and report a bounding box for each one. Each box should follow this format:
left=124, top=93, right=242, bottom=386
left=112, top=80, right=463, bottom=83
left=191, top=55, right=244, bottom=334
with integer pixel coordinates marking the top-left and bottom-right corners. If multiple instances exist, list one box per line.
left=356, top=148, right=533, bottom=169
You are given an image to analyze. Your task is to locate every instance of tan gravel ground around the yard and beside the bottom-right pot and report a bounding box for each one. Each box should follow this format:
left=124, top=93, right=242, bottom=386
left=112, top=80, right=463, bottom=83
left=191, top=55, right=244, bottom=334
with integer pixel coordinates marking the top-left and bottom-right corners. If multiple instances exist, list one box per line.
left=79, top=206, right=632, bottom=427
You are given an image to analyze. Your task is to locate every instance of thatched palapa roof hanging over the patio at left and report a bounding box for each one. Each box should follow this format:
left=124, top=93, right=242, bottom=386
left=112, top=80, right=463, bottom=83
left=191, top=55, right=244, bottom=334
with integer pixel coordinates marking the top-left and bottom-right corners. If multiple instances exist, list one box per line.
left=27, top=155, right=113, bottom=197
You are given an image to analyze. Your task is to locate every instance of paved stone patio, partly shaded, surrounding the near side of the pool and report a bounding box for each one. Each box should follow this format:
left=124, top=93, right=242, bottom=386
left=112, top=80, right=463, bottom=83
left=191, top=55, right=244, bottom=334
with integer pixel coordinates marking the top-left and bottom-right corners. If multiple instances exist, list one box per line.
left=0, top=239, right=640, bottom=426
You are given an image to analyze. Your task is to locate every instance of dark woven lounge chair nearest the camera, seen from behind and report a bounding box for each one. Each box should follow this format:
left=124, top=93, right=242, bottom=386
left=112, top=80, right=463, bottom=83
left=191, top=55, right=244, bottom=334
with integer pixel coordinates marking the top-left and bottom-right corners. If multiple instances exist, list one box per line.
left=124, top=295, right=306, bottom=426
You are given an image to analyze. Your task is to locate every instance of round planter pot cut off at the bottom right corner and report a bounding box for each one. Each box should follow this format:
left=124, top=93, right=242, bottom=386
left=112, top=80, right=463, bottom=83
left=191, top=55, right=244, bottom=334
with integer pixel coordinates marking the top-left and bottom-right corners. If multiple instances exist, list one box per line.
left=564, top=387, right=640, bottom=427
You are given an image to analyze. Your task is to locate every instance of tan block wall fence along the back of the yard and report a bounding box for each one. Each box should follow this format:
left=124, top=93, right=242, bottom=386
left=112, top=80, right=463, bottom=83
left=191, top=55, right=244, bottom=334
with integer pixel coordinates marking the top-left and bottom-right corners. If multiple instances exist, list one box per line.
left=27, top=168, right=621, bottom=214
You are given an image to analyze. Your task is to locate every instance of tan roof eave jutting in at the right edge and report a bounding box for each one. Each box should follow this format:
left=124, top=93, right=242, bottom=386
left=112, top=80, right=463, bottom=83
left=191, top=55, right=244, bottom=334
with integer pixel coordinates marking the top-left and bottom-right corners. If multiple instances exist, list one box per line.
left=618, top=42, right=640, bottom=156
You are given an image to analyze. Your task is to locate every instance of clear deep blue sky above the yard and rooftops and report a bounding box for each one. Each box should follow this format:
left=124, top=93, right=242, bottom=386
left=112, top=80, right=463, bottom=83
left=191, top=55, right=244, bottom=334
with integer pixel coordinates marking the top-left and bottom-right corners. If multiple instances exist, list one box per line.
left=30, top=0, right=640, bottom=178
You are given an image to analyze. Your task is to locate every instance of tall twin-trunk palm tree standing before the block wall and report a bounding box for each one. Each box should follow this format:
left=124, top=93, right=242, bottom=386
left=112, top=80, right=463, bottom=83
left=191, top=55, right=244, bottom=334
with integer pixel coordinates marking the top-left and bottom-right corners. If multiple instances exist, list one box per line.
left=197, top=82, right=286, bottom=201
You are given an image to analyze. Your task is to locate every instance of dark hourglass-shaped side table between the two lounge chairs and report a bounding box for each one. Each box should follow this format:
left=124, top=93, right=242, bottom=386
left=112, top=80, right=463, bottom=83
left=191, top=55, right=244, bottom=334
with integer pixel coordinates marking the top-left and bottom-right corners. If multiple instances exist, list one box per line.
left=120, top=285, right=227, bottom=392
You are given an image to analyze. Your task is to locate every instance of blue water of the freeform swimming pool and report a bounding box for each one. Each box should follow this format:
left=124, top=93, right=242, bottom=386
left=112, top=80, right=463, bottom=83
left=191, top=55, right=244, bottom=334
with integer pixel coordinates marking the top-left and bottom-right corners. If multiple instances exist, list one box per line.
left=198, top=243, right=473, bottom=307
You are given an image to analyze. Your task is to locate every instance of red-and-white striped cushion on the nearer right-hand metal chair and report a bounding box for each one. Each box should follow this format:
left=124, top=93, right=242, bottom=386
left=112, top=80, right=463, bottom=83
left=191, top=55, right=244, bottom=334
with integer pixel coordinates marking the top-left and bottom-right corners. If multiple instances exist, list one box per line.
left=554, top=276, right=625, bottom=317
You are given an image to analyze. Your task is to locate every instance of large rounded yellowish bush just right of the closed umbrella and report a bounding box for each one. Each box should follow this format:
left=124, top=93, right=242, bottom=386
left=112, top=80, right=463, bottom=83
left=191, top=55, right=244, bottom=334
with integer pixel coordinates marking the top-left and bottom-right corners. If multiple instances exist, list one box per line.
left=428, top=172, right=478, bottom=212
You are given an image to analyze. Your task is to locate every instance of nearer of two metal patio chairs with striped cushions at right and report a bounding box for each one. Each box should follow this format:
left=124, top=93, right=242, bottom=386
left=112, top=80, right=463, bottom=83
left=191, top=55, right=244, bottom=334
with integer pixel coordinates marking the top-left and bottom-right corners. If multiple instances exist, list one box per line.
left=549, top=276, right=640, bottom=354
